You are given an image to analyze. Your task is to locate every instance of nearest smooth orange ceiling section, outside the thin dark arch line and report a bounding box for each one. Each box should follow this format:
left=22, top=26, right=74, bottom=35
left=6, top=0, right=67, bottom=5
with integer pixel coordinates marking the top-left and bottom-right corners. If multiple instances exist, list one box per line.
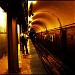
left=33, top=1, right=75, bottom=25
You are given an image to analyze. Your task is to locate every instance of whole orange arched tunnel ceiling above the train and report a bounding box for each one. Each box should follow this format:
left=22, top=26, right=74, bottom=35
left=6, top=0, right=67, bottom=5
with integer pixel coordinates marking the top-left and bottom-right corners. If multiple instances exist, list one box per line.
left=28, top=1, right=75, bottom=31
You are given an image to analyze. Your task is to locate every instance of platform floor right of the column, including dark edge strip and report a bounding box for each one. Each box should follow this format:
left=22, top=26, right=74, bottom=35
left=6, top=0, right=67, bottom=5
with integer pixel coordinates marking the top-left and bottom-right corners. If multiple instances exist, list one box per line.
left=19, top=39, right=47, bottom=74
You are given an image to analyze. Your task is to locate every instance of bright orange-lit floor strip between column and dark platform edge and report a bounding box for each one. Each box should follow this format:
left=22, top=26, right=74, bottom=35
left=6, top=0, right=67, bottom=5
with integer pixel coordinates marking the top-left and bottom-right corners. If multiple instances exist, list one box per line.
left=18, top=40, right=32, bottom=74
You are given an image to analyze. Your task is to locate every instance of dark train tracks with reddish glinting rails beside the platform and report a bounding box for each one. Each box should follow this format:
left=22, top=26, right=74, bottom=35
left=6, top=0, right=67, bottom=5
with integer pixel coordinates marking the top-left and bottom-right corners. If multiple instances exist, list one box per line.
left=35, top=43, right=73, bottom=75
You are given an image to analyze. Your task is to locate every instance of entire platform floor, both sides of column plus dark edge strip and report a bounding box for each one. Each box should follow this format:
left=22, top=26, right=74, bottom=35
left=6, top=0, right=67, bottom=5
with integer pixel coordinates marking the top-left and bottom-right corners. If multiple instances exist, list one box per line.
left=0, top=39, right=47, bottom=74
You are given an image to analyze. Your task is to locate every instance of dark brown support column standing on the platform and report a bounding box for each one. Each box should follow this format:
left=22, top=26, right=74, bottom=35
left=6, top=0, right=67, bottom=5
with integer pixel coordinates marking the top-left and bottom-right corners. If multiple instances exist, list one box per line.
left=7, top=10, right=19, bottom=73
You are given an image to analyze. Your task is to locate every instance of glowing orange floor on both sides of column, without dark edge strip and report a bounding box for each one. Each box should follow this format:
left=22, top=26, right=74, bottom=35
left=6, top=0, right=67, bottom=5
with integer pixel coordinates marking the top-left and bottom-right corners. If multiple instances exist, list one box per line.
left=0, top=40, right=31, bottom=74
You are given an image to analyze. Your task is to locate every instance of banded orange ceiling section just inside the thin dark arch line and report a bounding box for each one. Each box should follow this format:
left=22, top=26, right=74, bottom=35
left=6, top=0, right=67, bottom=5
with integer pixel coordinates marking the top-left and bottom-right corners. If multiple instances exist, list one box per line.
left=32, top=11, right=60, bottom=29
